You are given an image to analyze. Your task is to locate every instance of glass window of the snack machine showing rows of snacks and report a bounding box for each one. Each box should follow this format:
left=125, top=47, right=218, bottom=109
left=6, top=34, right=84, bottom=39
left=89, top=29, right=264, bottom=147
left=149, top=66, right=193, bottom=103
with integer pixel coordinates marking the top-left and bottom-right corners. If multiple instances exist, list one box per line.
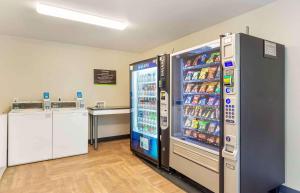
left=171, top=41, right=221, bottom=151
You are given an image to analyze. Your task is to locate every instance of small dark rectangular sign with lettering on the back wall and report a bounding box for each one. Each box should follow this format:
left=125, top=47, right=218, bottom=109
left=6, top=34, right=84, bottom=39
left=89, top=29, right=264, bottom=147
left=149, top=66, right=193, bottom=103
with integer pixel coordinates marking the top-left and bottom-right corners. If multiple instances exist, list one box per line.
left=94, top=69, right=117, bottom=85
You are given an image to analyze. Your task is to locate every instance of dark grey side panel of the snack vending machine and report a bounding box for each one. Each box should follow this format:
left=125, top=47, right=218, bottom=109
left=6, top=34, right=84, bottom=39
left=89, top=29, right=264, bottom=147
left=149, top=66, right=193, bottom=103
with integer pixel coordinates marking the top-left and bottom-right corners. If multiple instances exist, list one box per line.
left=240, top=34, right=285, bottom=193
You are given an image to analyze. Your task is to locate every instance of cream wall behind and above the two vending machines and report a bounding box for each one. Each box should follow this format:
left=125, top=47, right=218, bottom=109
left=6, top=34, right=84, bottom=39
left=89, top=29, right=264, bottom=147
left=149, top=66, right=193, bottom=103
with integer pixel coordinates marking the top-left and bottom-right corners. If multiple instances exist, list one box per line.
left=142, top=0, right=300, bottom=190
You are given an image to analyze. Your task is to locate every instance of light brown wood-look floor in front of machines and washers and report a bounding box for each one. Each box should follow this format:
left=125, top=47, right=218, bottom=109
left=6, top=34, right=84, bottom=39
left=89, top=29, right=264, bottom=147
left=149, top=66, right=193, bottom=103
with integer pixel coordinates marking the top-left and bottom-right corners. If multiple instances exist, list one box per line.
left=0, top=140, right=184, bottom=193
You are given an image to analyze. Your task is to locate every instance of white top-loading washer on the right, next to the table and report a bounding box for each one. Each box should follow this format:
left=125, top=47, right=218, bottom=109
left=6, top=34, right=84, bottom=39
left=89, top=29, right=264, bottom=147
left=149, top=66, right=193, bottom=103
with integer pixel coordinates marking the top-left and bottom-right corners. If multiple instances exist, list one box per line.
left=52, top=108, right=88, bottom=159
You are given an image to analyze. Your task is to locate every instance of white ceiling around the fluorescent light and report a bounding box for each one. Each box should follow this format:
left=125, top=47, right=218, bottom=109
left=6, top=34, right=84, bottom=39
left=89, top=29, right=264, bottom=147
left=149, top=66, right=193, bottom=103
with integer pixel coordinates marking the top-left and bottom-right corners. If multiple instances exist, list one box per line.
left=0, top=0, right=273, bottom=52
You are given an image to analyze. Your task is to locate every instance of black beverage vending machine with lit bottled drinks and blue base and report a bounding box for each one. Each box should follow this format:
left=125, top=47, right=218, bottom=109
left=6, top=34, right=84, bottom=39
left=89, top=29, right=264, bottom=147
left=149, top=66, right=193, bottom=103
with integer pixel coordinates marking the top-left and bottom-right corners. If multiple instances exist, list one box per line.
left=130, top=55, right=169, bottom=169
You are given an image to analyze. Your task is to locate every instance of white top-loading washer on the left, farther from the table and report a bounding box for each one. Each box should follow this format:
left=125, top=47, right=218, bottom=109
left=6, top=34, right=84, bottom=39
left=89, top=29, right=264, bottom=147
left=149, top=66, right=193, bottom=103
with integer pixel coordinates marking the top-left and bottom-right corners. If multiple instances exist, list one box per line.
left=8, top=109, right=52, bottom=166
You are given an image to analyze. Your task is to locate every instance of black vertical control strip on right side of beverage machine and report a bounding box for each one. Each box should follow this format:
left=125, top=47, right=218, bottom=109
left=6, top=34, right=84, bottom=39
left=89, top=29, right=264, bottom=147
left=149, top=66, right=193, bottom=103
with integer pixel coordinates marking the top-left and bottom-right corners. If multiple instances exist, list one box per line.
left=158, top=54, right=170, bottom=170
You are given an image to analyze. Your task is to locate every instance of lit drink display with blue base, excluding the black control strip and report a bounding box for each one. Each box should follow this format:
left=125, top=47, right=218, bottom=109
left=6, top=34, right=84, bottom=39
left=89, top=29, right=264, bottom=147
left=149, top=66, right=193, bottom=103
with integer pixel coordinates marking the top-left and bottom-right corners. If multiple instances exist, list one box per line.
left=130, top=59, right=158, bottom=161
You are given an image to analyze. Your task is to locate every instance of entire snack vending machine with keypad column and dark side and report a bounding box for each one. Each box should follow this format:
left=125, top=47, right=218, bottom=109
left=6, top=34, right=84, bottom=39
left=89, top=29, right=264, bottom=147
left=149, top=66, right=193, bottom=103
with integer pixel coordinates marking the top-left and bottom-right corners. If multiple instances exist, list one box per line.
left=170, top=33, right=285, bottom=193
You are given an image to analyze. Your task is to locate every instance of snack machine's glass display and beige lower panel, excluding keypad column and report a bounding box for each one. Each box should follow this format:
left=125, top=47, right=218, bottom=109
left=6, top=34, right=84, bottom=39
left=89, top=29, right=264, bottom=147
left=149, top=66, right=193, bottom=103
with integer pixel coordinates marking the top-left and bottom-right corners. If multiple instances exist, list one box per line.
left=170, top=40, right=223, bottom=192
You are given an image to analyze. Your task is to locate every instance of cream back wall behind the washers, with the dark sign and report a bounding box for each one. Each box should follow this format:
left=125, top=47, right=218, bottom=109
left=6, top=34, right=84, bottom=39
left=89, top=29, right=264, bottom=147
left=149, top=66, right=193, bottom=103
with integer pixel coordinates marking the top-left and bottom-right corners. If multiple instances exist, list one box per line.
left=0, top=36, right=137, bottom=137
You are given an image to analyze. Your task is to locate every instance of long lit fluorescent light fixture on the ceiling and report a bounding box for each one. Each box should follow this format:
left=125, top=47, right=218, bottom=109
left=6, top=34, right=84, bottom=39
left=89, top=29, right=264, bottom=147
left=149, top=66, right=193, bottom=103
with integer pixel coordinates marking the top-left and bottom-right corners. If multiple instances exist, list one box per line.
left=36, top=2, right=128, bottom=30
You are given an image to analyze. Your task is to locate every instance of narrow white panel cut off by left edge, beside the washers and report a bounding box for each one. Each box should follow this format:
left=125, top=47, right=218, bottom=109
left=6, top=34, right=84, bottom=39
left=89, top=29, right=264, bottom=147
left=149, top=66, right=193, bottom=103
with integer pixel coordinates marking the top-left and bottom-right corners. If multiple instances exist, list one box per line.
left=0, top=114, right=7, bottom=180
